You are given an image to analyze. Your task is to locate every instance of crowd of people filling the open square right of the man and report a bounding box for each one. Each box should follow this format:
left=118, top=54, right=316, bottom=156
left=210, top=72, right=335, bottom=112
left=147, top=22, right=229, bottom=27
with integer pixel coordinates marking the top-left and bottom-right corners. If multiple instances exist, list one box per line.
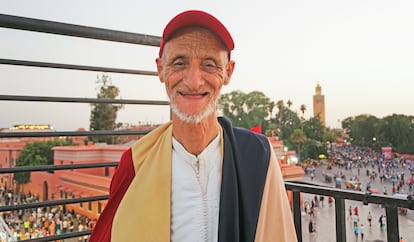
left=303, top=146, right=414, bottom=241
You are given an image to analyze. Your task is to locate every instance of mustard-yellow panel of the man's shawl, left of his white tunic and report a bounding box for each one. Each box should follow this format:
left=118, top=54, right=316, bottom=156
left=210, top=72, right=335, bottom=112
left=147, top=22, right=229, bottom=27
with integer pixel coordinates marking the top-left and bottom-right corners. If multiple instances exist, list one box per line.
left=111, top=122, right=172, bottom=242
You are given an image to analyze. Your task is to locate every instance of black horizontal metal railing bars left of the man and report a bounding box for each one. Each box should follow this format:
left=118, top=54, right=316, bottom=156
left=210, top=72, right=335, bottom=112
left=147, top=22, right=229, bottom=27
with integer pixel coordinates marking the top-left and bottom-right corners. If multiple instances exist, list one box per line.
left=0, top=14, right=169, bottom=241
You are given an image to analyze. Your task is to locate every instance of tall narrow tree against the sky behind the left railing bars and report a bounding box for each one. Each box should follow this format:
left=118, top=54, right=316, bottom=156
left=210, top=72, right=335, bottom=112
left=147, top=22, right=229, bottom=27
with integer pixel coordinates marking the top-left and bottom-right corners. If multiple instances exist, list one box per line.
left=89, top=75, right=123, bottom=144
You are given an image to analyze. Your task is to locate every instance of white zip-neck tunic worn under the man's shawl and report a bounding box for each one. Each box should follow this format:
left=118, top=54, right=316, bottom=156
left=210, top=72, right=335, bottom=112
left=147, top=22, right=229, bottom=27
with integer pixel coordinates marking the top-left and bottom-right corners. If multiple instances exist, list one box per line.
left=171, top=135, right=221, bottom=242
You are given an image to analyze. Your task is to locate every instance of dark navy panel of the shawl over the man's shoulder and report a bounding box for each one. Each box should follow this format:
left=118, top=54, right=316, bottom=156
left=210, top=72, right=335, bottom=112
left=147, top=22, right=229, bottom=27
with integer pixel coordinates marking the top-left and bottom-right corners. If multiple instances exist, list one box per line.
left=218, top=118, right=270, bottom=242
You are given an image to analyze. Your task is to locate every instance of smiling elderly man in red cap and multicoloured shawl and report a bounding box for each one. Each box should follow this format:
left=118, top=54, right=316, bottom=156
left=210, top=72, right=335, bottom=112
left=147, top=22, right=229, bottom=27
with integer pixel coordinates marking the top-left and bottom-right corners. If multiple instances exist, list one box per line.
left=90, top=10, right=297, bottom=242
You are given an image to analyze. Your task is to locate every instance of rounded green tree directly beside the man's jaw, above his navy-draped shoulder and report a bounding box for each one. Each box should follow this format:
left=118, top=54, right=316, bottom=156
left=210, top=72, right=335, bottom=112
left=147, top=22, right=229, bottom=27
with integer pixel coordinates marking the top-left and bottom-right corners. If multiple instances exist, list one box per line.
left=219, top=91, right=274, bottom=129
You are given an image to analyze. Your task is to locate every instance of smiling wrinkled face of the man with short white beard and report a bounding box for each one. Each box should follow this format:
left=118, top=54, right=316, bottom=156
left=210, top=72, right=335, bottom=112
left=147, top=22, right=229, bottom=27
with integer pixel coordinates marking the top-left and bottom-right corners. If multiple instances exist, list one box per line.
left=157, top=28, right=234, bottom=123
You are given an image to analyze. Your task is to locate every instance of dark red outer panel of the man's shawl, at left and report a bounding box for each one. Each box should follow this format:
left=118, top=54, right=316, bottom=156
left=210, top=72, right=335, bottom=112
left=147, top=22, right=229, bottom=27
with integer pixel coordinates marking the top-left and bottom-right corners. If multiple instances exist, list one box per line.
left=89, top=149, right=135, bottom=242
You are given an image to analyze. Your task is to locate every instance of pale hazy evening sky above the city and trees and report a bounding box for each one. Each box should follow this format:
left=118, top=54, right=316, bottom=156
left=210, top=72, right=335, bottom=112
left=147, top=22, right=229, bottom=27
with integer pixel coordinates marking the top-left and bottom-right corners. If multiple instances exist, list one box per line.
left=0, top=0, right=414, bottom=131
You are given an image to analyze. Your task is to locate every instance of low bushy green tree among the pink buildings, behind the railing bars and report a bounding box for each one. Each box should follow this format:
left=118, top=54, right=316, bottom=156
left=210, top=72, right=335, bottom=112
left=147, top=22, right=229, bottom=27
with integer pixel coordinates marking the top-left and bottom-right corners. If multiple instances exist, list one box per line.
left=13, top=139, right=73, bottom=184
